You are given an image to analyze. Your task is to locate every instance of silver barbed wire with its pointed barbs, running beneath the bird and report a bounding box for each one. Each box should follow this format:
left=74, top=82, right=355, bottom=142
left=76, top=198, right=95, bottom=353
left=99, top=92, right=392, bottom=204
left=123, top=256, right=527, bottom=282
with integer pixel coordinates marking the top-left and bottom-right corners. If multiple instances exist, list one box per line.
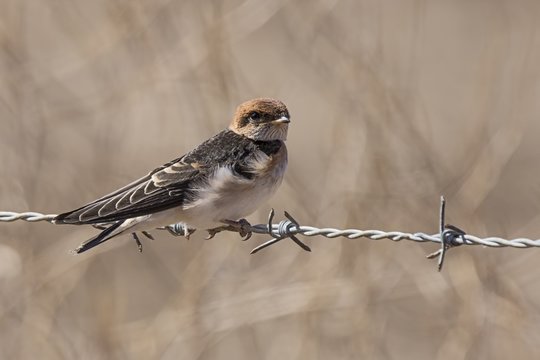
left=0, top=196, right=540, bottom=271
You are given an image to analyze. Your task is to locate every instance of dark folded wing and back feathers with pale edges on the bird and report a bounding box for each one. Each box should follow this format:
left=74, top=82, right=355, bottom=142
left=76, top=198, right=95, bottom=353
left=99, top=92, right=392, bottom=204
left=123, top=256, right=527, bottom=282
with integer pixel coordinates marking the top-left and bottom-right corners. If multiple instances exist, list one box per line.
left=54, top=130, right=281, bottom=224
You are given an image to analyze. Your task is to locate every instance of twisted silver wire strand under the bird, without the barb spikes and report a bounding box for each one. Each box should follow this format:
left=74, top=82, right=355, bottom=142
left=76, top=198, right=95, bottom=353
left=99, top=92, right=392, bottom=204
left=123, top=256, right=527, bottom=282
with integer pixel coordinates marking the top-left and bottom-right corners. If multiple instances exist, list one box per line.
left=0, top=211, right=540, bottom=249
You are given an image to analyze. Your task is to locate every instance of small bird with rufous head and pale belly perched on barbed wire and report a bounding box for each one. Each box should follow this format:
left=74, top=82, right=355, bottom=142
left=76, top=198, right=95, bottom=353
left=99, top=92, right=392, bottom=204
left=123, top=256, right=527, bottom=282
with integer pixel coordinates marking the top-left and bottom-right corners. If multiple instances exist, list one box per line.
left=53, top=98, right=290, bottom=253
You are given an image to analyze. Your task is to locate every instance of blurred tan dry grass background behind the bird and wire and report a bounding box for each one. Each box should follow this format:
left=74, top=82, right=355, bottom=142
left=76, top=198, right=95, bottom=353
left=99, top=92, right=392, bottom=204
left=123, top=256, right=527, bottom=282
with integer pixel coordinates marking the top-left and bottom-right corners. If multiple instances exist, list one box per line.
left=0, top=0, right=540, bottom=359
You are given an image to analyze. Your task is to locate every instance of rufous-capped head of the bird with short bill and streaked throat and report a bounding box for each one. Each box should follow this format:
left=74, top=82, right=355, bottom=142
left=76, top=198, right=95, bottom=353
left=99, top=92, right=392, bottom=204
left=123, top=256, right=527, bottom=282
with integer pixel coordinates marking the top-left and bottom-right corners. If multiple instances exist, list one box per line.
left=229, top=98, right=291, bottom=141
